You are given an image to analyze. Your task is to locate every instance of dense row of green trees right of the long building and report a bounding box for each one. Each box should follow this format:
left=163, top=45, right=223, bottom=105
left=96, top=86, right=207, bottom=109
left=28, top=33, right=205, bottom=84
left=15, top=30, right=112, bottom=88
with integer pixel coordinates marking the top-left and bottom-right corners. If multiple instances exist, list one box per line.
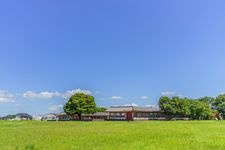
left=159, top=94, right=225, bottom=120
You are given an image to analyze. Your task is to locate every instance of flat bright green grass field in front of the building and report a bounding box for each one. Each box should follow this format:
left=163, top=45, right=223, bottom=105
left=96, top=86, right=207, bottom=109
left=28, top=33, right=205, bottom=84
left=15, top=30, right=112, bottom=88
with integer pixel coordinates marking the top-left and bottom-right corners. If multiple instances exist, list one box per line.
left=0, top=121, right=225, bottom=150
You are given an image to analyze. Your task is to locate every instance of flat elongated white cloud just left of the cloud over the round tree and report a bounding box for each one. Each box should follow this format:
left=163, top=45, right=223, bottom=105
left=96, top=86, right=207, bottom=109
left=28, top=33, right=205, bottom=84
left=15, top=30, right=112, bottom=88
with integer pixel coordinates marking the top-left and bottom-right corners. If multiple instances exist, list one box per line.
left=23, top=91, right=61, bottom=99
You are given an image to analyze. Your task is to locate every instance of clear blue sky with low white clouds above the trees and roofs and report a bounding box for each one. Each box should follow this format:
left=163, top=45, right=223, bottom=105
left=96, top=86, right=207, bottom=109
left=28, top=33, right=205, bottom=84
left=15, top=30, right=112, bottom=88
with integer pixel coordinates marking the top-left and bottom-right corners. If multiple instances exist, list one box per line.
left=0, top=0, right=225, bottom=116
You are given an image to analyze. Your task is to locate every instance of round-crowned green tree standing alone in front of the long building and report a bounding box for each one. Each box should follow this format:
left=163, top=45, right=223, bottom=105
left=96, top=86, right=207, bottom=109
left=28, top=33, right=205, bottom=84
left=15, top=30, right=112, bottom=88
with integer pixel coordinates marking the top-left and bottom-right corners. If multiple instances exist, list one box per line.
left=63, top=93, right=96, bottom=120
